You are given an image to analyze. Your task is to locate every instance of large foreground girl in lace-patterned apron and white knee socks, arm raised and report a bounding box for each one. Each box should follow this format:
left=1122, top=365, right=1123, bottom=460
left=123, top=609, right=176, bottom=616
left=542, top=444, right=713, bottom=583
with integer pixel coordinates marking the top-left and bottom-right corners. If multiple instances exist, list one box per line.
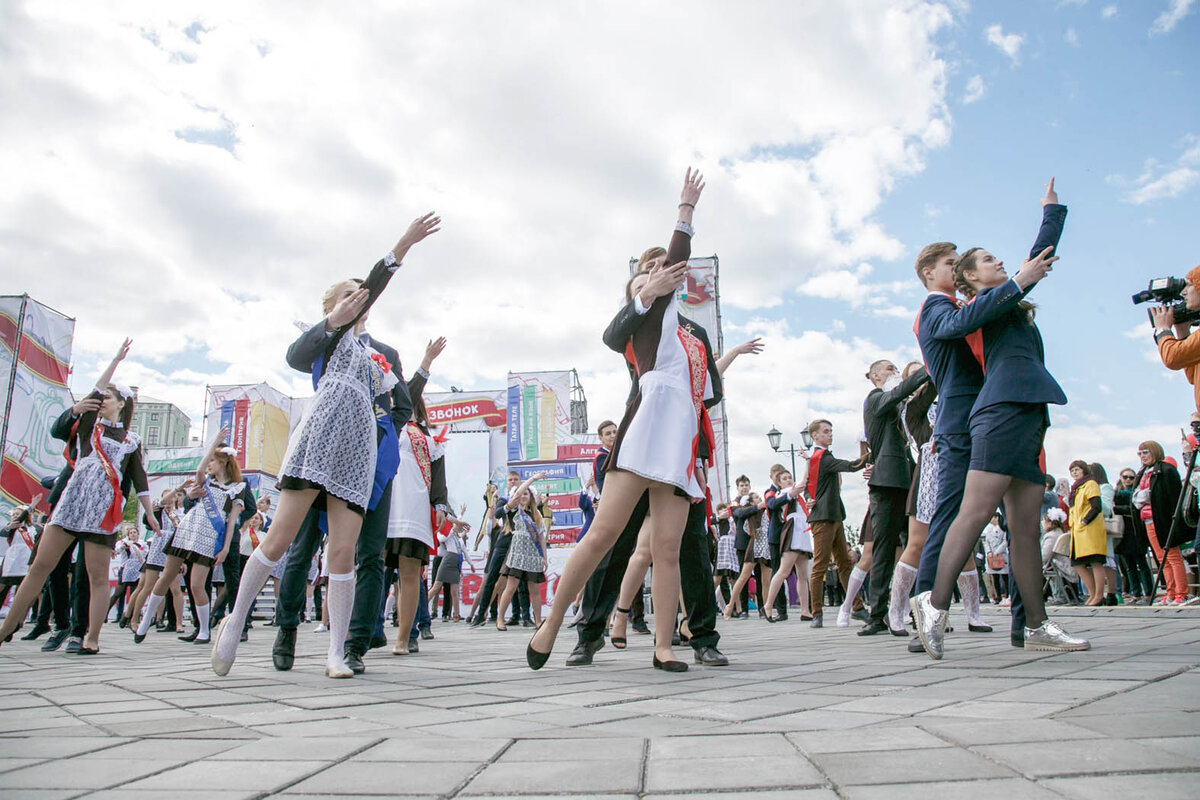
left=211, top=213, right=440, bottom=678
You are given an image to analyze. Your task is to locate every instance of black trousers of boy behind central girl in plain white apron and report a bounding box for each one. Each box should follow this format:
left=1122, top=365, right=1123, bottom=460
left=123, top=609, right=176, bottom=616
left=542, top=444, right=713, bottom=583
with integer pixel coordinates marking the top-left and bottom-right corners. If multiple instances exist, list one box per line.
left=578, top=493, right=721, bottom=650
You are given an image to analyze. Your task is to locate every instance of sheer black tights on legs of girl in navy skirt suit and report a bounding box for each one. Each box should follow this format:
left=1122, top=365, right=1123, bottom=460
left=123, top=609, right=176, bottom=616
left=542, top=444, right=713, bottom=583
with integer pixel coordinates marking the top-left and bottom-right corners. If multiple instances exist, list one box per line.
left=930, top=470, right=1046, bottom=627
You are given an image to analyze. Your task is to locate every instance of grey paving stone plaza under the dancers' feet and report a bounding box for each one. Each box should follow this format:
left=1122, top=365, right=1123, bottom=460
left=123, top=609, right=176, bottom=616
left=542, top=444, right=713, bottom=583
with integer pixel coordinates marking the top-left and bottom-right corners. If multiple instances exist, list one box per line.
left=0, top=606, right=1200, bottom=800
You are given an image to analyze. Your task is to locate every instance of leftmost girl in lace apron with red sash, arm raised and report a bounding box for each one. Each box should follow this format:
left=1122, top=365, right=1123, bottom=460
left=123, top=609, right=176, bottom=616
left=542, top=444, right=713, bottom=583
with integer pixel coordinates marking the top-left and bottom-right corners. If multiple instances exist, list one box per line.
left=0, top=339, right=158, bottom=656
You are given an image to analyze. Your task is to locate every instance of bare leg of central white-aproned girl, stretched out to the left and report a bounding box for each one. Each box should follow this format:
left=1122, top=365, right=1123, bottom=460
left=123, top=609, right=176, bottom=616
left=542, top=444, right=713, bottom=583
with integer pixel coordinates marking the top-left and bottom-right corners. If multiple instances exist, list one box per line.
left=529, top=470, right=652, bottom=654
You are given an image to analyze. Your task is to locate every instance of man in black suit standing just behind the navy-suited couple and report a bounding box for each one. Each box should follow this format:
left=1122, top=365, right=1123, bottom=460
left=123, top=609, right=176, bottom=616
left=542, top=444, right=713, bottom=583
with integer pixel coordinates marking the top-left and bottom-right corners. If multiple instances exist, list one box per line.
left=858, top=360, right=929, bottom=636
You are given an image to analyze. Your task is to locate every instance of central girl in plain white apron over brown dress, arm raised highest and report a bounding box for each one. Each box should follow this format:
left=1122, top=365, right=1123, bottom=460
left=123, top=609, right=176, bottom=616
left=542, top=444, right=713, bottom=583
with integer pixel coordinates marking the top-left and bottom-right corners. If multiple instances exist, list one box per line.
left=526, top=169, right=721, bottom=672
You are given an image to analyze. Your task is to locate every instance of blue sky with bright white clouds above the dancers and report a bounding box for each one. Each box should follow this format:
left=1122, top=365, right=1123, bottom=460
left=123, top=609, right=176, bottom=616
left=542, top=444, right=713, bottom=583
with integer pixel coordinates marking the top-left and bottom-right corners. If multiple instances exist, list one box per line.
left=0, top=0, right=1200, bottom=519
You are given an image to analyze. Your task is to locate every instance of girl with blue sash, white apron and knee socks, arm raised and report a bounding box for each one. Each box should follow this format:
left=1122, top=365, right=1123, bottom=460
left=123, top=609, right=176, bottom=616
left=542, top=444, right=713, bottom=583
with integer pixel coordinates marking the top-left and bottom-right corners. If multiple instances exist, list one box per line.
left=133, top=428, right=246, bottom=644
